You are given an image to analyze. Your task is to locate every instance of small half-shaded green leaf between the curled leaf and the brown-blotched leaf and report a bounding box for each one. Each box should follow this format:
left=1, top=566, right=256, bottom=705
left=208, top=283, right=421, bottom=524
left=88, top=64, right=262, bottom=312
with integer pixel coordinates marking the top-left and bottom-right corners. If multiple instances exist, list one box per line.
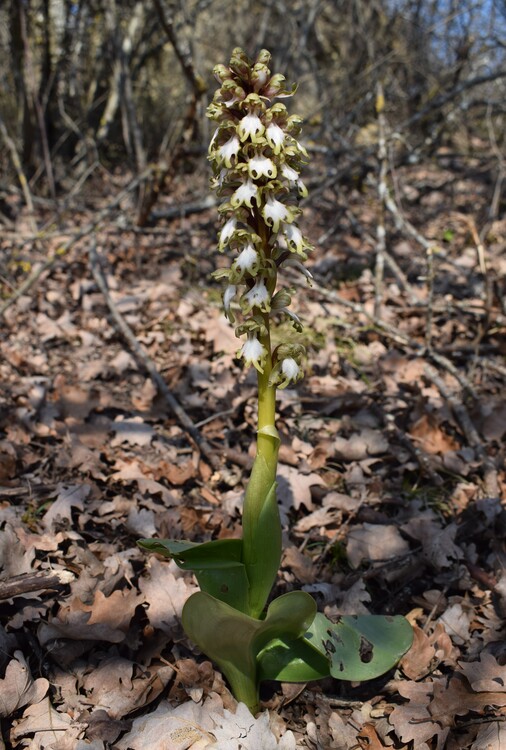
left=258, top=638, right=330, bottom=682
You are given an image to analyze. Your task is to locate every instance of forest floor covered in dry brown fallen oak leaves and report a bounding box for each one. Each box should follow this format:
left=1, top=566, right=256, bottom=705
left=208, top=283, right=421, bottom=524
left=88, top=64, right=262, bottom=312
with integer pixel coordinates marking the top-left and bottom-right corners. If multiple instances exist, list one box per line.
left=0, top=144, right=506, bottom=750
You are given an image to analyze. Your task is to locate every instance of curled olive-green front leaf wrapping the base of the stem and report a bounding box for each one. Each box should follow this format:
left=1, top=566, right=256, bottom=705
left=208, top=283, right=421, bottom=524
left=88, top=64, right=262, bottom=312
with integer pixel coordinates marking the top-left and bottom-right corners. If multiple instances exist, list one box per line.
left=182, top=591, right=316, bottom=710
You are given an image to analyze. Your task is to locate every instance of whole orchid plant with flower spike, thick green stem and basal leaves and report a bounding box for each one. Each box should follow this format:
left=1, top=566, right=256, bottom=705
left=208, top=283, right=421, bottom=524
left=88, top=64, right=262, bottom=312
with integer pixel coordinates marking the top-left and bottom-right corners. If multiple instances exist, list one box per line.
left=139, top=48, right=412, bottom=712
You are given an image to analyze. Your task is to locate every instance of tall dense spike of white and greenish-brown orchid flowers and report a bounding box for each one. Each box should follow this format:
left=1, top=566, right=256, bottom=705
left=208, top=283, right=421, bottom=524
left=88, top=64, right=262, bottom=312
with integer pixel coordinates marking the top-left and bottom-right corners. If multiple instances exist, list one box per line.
left=208, top=48, right=311, bottom=388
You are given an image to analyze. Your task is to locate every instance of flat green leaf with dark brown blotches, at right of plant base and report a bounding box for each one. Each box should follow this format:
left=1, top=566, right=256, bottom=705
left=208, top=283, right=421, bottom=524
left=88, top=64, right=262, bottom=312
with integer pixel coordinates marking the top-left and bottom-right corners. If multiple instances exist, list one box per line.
left=305, top=614, right=413, bottom=682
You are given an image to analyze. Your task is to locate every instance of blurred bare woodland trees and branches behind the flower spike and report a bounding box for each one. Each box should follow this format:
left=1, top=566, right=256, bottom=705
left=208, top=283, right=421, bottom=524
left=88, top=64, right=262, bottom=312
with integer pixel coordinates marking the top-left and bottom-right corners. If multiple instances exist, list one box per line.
left=0, top=0, right=506, bottom=224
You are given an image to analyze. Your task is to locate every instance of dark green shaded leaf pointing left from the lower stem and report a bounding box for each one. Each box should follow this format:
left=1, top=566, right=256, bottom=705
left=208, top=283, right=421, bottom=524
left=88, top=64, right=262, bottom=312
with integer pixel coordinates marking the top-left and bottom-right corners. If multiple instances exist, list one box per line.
left=138, top=539, right=249, bottom=612
